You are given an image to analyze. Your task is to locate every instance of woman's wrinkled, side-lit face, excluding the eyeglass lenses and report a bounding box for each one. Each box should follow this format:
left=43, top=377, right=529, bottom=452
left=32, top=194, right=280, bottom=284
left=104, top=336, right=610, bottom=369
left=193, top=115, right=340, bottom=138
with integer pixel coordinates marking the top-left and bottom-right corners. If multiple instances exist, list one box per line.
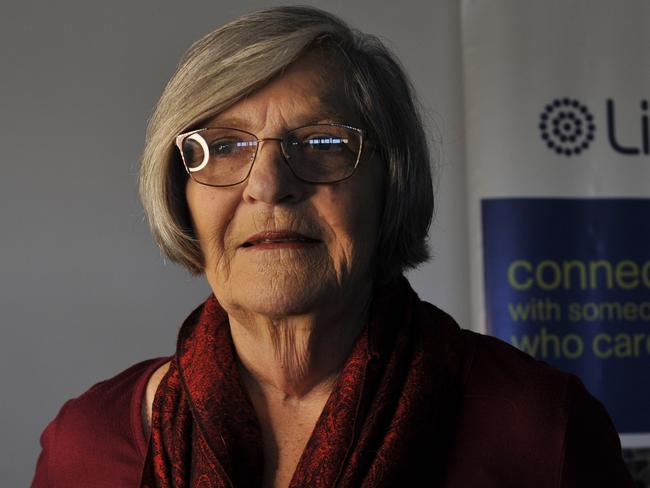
left=186, top=54, right=383, bottom=318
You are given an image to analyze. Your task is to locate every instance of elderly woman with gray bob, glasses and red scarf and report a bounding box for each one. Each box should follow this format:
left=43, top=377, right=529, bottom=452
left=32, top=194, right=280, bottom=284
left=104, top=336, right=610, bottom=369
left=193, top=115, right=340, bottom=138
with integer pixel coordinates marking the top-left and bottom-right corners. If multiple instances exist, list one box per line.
left=33, top=7, right=631, bottom=487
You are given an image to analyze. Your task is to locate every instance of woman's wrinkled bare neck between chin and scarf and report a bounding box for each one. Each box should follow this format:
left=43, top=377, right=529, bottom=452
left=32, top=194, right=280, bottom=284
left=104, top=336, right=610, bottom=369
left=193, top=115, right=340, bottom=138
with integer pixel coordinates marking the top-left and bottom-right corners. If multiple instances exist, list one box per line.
left=229, top=285, right=371, bottom=402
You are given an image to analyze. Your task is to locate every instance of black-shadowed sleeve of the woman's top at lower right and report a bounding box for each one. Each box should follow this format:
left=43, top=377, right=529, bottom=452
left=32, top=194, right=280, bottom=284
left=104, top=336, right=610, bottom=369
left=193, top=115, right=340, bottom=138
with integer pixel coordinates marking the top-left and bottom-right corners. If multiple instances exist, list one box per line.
left=562, top=376, right=634, bottom=488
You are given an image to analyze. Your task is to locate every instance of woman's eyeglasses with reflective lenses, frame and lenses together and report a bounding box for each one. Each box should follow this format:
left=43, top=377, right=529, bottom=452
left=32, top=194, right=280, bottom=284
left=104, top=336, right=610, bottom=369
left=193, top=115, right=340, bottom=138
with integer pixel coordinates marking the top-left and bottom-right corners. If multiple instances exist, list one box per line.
left=176, top=124, right=363, bottom=187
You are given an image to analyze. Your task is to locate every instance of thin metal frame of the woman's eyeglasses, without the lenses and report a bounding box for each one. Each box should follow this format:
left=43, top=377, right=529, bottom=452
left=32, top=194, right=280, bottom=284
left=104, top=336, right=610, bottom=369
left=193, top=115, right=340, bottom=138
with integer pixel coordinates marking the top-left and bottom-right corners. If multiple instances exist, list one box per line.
left=175, top=123, right=365, bottom=188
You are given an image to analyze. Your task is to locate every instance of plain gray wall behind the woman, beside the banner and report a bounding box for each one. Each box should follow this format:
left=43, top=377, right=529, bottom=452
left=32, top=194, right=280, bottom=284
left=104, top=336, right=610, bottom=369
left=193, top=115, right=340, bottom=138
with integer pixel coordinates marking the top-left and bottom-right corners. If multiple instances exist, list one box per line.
left=0, top=0, right=469, bottom=487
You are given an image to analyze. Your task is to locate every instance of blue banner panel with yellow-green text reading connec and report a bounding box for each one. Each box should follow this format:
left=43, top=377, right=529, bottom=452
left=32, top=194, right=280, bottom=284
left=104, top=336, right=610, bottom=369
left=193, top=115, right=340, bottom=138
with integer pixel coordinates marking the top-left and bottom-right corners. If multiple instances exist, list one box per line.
left=481, top=198, right=650, bottom=433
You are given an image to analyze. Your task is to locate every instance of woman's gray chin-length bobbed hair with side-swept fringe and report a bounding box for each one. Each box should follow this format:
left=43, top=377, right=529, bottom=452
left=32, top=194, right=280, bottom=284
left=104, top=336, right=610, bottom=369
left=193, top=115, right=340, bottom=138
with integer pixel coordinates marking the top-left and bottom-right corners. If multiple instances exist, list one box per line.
left=140, top=7, right=433, bottom=281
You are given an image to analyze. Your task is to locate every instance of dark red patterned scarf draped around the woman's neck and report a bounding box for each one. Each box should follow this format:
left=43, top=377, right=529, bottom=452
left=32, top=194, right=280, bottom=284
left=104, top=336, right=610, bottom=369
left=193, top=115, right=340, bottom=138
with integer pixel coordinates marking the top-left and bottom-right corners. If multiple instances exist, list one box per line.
left=142, top=278, right=462, bottom=488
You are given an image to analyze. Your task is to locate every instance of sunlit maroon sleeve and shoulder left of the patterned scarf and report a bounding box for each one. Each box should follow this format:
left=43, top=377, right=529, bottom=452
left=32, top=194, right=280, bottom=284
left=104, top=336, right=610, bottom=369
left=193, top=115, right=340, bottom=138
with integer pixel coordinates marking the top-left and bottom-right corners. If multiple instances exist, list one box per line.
left=32, top=358, right=168, bottom=488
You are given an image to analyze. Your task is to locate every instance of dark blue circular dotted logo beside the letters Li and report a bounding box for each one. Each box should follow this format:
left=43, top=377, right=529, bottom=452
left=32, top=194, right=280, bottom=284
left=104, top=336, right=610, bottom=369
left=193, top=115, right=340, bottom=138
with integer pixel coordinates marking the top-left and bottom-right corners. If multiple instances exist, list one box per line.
left=539, top=98, right=596, bottom=156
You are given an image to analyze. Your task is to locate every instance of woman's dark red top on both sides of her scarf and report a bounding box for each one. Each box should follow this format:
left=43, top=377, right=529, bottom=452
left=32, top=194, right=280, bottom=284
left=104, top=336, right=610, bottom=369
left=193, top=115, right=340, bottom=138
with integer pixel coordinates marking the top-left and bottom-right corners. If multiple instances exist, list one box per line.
left=32, top=311, right=633, bottom=488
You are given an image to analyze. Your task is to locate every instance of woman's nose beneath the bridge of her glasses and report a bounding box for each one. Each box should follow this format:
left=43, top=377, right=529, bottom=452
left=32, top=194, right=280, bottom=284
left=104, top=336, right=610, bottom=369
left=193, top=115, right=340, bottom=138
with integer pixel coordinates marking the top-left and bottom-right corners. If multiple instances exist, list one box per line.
left=243, top=139, right=306, bottom=204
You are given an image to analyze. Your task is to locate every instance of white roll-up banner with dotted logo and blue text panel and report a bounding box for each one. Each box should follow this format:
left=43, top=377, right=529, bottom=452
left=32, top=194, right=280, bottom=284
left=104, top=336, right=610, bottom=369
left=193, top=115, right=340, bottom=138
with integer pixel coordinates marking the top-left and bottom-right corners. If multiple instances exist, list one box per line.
left=461, top=0, right=650, bottom=447
